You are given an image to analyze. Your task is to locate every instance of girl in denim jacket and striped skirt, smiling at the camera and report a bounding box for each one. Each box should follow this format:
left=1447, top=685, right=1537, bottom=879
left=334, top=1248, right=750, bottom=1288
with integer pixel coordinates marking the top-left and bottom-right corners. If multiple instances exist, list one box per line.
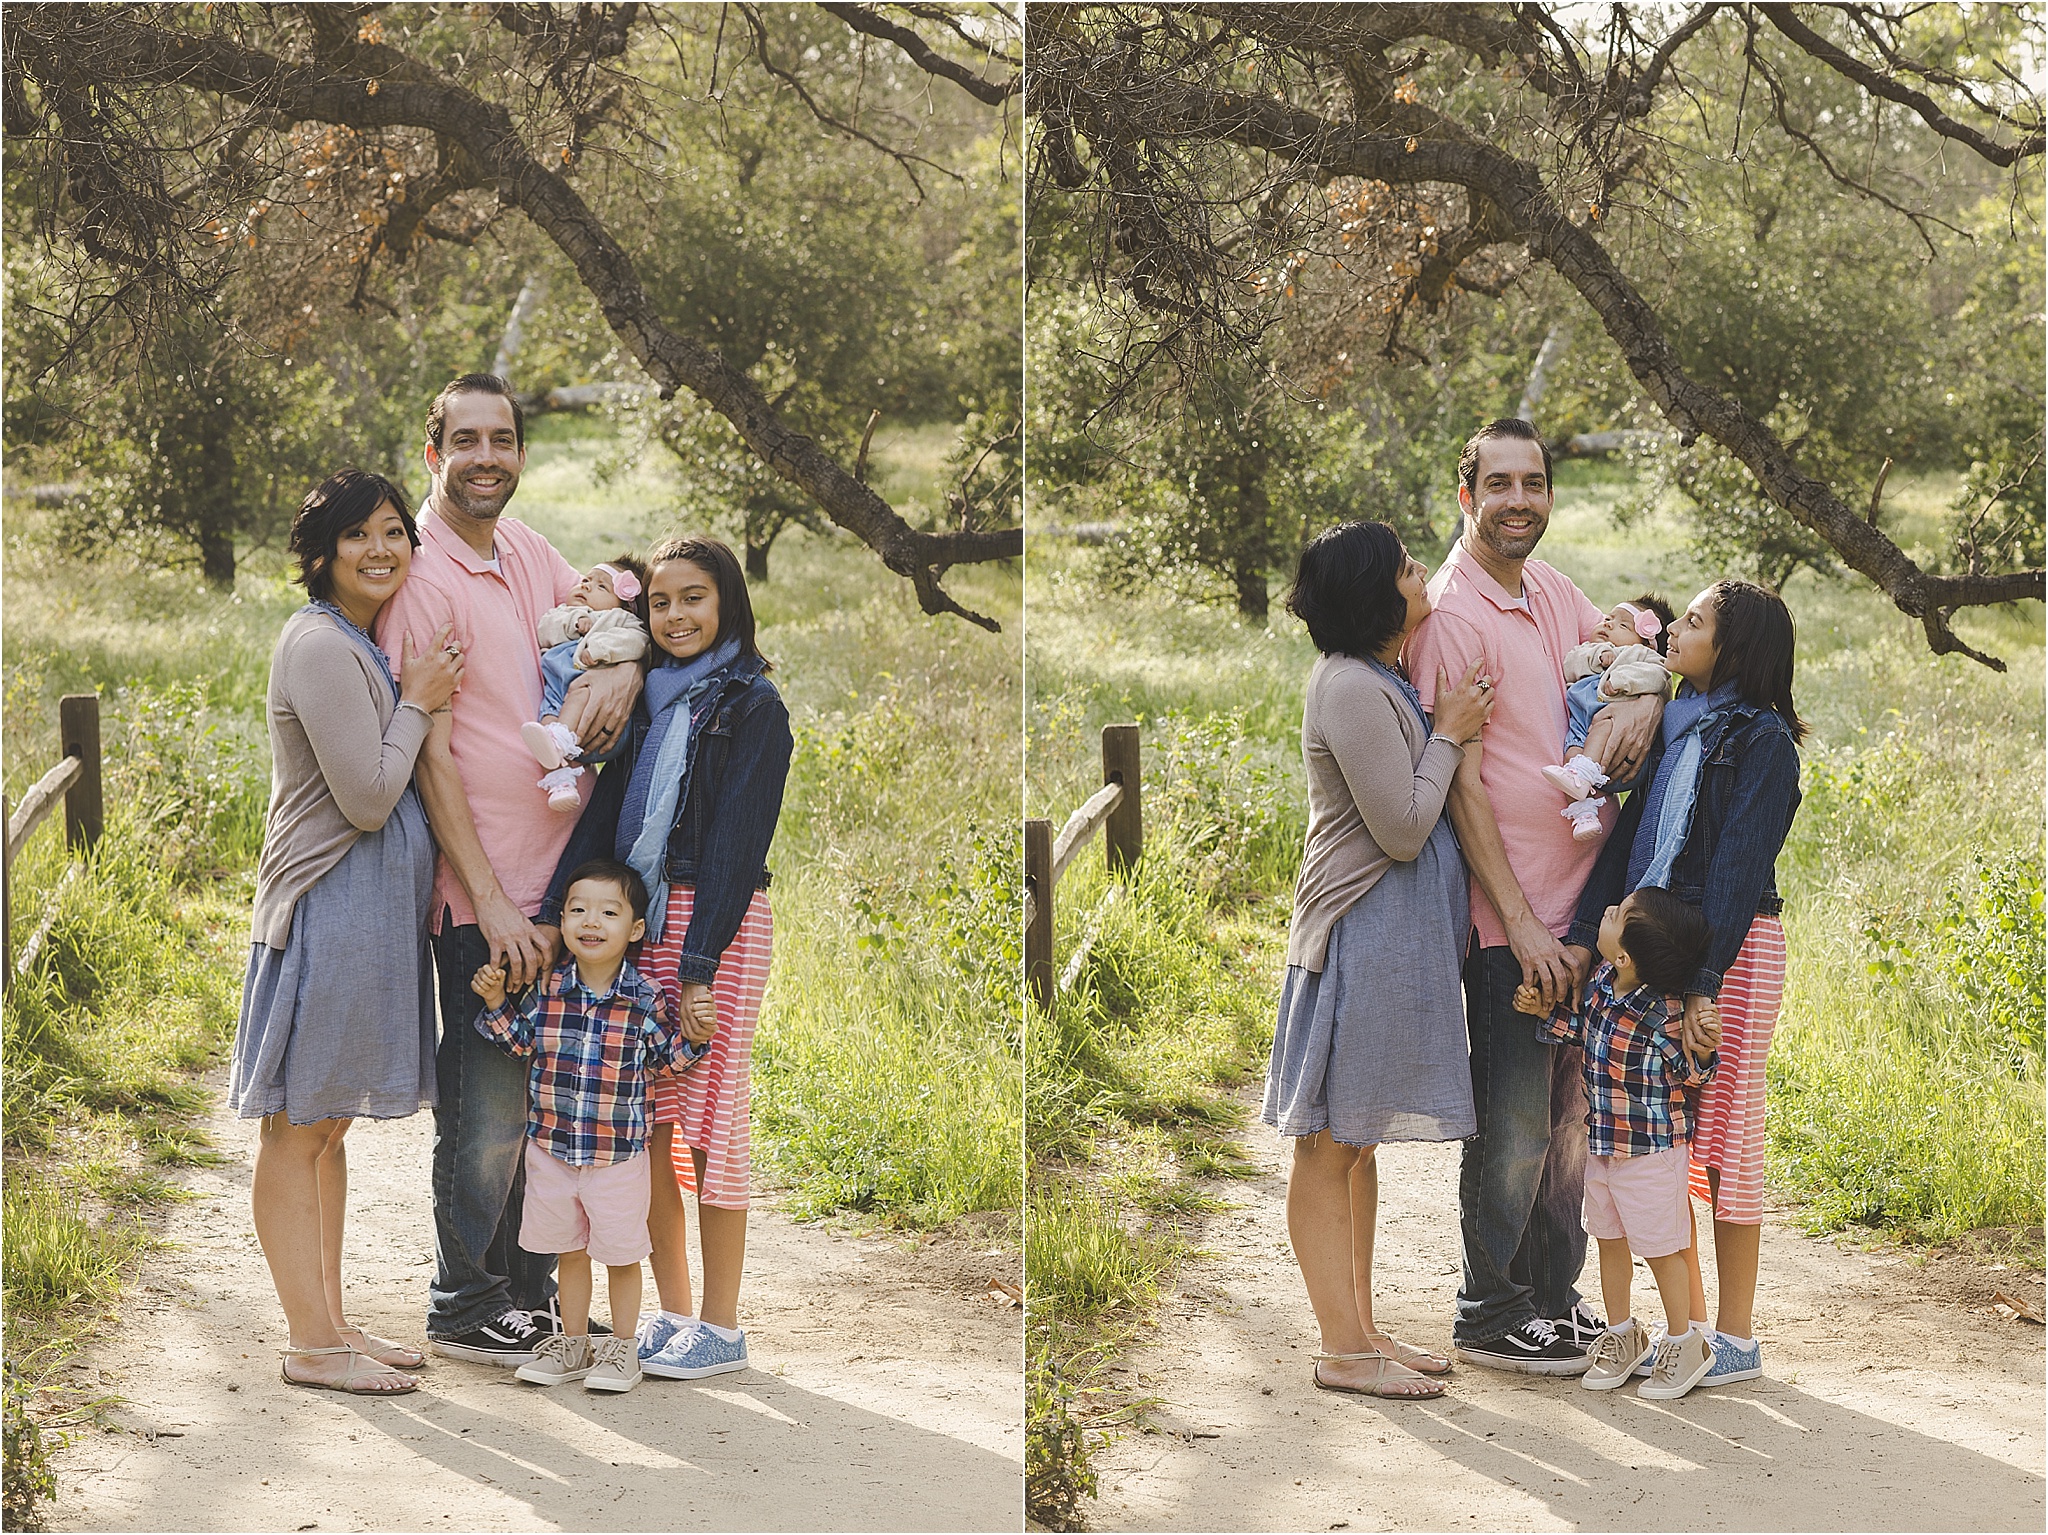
left=541, top=538, right=793, bottom=1379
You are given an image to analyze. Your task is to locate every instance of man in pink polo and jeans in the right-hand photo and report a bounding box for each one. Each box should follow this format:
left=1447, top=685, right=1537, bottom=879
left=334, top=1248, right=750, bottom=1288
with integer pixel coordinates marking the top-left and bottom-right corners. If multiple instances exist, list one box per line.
left=1407, top=418, right=1663, bottom=1375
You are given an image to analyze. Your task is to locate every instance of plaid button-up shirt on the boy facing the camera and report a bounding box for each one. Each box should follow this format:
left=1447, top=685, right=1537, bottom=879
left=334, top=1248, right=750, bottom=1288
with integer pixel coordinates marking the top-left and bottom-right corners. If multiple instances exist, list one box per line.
left=477, top=960, right=709, bottom=1167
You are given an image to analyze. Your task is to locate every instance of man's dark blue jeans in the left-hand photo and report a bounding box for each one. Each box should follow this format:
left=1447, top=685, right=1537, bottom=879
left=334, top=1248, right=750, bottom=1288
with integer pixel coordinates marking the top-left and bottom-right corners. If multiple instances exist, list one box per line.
left=426, top=921, right=555, bottom=1339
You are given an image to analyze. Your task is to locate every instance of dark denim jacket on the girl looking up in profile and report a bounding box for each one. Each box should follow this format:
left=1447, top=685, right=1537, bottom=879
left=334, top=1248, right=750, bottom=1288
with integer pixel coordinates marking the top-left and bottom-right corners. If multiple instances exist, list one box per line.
left=1565, top=698, right=1800, bottom=1011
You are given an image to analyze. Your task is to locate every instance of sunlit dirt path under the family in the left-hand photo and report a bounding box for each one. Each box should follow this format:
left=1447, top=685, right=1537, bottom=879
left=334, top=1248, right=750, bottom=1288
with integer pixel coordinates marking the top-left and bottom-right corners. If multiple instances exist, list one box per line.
left=49, top=1072, right=1024, bottom=1531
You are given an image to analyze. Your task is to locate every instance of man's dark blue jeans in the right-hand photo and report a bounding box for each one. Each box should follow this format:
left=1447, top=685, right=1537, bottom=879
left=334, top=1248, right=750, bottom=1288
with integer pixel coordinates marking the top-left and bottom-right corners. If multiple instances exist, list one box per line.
left=1452, top=944, right=1585, bottom=1343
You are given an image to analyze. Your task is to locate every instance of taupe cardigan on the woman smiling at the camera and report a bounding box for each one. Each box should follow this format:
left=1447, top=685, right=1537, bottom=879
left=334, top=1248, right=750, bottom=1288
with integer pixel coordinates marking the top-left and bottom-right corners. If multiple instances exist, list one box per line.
left=252, top=610, right=432, bottom=950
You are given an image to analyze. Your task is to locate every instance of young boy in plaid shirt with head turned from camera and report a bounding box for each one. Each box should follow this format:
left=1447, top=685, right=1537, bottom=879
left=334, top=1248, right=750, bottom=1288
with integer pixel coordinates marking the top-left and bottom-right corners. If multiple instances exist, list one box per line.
left=1516, top=888, right=1716, bottom=1398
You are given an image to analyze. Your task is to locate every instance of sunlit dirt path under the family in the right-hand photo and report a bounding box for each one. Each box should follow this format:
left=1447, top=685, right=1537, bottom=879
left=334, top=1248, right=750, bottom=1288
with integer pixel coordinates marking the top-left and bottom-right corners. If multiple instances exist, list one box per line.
left=1087, top=1088, right=2048, bottom=1531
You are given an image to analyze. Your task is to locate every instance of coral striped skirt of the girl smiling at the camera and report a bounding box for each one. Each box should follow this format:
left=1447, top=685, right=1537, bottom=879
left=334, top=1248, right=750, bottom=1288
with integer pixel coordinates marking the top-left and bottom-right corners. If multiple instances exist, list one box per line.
left=633, top=884, right=774, bottom=1210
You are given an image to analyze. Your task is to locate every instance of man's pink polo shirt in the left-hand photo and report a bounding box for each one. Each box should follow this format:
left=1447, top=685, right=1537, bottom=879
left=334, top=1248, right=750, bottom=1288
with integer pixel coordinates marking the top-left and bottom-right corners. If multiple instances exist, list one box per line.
left=377, top=510, right=592, bottom=933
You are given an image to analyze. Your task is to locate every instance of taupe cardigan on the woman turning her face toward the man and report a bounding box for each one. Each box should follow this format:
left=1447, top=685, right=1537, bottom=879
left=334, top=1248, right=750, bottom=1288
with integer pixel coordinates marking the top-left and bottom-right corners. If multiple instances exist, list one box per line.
left=1286, top=655, right=1464, bottom=972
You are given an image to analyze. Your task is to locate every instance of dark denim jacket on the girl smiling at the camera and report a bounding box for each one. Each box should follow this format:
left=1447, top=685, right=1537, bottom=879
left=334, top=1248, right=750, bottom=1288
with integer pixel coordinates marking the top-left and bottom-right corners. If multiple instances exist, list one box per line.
left=537, top=655, right=795, bottom=984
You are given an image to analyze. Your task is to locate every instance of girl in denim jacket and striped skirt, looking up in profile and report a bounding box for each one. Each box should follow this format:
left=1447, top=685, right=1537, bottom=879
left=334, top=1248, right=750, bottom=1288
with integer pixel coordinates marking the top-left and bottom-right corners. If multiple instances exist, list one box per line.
left=1565, top=581, right=1806, bottom=1386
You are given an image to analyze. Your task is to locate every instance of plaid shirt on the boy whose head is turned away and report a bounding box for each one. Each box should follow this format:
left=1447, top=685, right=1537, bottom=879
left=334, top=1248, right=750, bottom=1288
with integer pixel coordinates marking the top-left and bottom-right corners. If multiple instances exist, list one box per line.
left=1542, top=960, right=1720, bottom=1156
